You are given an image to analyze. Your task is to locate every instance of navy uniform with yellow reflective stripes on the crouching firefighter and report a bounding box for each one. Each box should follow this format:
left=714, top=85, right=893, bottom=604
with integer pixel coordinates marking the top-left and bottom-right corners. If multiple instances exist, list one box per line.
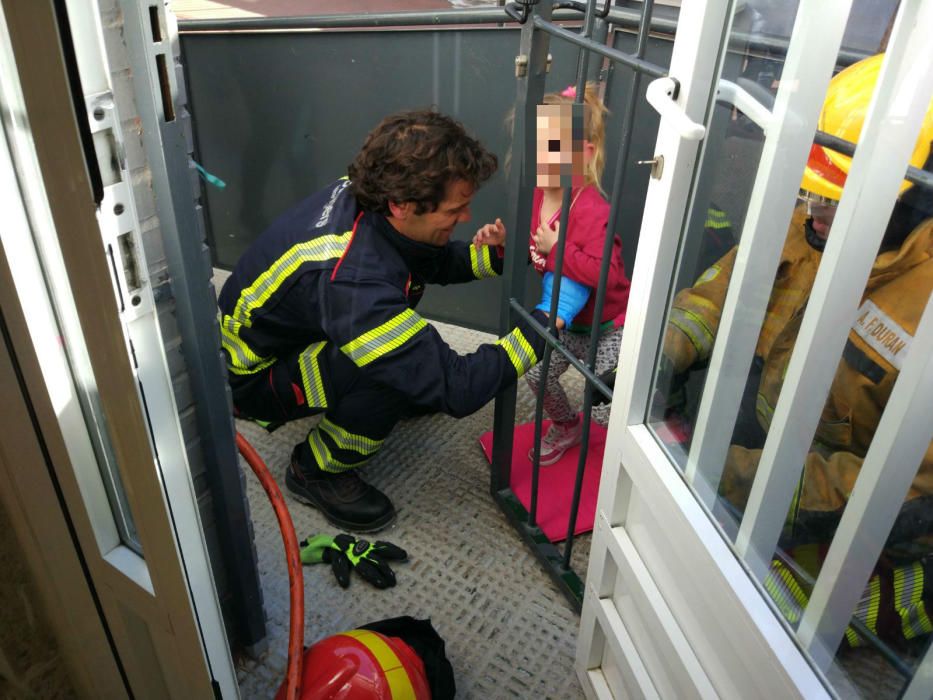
left=219, top=178, right=545, bottom=471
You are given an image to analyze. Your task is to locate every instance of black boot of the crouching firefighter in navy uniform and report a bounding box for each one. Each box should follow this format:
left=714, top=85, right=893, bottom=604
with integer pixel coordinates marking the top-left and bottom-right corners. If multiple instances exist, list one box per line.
left=285, top=443, right=395, bottom=532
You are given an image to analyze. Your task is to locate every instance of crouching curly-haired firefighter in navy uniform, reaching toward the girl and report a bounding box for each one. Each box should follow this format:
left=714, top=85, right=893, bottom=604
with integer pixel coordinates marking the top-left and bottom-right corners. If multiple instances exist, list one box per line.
left=219, top=111, right=546, bottom=532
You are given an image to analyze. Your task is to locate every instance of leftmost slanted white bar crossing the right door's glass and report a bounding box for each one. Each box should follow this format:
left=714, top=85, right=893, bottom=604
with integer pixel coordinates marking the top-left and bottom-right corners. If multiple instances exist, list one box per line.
left=685, top=0, right=852, bottom=508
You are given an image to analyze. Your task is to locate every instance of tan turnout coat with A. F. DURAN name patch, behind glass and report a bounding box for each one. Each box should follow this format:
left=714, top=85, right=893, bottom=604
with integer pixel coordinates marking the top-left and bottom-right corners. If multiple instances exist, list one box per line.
left=664, top=208, right=933, bottom=541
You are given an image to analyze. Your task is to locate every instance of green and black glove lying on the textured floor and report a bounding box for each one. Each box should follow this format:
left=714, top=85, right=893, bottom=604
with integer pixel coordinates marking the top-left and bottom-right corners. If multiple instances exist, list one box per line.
left=301, top=534, right=408, bottom=588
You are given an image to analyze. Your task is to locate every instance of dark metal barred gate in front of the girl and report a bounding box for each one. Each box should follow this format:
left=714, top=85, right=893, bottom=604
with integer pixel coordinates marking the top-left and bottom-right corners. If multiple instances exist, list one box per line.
left=490, top=0, right=667, bottom=610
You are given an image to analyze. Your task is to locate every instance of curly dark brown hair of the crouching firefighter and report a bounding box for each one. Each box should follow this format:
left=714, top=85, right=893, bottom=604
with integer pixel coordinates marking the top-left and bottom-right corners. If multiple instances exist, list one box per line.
left=348, top=110, right=498, bottom=215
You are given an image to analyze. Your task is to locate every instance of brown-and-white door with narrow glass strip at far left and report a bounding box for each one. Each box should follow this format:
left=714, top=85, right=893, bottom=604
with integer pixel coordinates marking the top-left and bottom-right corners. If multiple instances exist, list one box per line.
left=0, top=3, right=238, bottom=697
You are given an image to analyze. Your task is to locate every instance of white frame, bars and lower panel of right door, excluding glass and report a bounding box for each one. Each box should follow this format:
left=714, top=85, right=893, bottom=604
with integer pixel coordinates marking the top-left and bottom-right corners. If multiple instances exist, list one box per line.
left=577, top=0, right=933, bottom=698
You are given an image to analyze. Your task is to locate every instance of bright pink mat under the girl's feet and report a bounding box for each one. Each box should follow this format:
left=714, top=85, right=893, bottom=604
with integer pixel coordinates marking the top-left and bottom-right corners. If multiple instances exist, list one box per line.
left=479, top=420, right=606, bottom=542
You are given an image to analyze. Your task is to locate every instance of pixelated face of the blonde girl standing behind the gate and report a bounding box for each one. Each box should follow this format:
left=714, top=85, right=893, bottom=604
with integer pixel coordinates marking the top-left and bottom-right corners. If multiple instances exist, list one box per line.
left=535, top=104, right=595, bottom=189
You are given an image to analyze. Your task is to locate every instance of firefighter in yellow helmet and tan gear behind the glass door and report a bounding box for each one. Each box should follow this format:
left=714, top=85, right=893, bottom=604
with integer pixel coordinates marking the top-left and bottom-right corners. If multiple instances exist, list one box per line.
left=663, top=55, right=933, bottom=641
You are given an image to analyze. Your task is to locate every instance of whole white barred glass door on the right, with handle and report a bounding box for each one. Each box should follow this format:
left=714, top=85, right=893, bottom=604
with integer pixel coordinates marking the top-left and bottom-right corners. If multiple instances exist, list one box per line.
left=578, top=0, right=933, bottom=697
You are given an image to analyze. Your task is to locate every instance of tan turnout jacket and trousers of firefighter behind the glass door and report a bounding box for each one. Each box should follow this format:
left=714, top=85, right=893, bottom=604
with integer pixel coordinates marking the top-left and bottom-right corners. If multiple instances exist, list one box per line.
left=664, top=208, right=933, bottom=643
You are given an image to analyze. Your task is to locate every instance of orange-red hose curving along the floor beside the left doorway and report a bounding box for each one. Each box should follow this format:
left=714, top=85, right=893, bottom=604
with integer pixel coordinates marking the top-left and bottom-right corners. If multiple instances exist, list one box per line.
left=236, top=433, right=305, bottom=700
